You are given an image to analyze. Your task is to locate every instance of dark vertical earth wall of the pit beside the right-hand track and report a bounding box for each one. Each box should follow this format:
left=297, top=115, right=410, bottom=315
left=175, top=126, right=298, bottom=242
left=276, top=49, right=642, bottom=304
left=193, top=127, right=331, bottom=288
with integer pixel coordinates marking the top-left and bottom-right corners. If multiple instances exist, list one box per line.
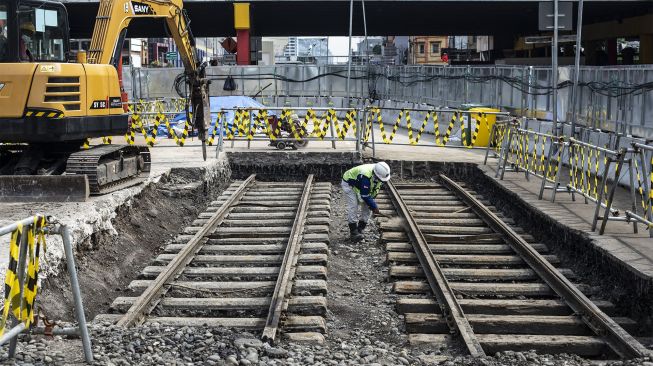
left=388, top=161, right=653, bottom=336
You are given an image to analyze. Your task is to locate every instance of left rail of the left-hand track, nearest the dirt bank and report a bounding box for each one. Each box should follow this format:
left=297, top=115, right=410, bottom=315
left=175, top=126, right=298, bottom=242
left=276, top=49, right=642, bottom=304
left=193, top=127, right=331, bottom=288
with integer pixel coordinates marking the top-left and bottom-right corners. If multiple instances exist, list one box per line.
left=117, top=174, right=256, bottom=327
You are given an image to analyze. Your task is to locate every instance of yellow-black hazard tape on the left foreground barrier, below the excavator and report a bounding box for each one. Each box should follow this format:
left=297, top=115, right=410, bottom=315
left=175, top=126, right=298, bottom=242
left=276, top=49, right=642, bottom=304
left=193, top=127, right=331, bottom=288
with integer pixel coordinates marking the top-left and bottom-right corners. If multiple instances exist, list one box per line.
left=0, top=216, right=47, bottom=336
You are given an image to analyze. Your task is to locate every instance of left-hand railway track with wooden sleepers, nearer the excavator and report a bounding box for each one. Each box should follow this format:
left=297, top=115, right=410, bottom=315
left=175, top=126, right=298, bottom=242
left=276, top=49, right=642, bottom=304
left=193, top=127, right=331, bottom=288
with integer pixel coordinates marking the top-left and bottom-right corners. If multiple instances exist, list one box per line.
left=96, top=175, right=331, bottom=341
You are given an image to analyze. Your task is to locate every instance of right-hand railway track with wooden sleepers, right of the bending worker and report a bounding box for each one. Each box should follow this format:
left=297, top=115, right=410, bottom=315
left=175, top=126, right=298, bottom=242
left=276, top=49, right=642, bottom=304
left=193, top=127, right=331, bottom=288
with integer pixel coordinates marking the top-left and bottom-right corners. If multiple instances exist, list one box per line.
left=378, top=175, right=649, bottom=358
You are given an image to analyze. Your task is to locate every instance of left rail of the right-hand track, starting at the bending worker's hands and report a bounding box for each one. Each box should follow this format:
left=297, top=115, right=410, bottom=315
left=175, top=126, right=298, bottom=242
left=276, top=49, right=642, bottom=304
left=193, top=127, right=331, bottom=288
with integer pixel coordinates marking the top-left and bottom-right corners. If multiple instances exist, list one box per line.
left=387, top=182, right=485, bottom=357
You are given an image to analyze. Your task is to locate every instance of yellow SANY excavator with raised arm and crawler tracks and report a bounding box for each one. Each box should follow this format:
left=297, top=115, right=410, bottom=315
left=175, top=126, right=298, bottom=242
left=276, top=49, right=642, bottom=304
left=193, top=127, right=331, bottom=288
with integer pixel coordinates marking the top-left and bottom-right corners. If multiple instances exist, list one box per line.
left=0, top=0, right=210, bottom=201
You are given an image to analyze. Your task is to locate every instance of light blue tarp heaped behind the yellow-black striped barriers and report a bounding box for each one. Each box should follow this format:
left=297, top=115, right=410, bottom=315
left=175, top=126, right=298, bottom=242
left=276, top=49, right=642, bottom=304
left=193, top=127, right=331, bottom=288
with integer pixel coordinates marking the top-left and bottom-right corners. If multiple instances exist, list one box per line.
left=162, top=95, right=278, bottom=136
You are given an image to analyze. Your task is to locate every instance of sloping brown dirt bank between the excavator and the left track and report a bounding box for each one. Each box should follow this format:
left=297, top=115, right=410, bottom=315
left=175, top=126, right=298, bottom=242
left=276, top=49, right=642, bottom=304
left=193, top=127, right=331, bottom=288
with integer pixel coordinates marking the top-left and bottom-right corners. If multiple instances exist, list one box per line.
left=39, top=168, right=230, bottom=321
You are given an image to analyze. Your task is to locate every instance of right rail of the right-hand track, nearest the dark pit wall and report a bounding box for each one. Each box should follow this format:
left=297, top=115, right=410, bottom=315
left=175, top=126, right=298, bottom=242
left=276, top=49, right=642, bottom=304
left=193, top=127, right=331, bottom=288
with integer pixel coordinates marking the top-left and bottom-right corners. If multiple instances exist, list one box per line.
left=440, top=174, right=651, bottom=358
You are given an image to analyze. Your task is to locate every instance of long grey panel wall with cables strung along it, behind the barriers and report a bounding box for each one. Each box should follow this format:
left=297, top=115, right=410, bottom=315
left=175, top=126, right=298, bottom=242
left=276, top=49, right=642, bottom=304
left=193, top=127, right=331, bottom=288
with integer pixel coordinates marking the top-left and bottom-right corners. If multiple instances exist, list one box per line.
left=124, top=65, right=653, bottom=138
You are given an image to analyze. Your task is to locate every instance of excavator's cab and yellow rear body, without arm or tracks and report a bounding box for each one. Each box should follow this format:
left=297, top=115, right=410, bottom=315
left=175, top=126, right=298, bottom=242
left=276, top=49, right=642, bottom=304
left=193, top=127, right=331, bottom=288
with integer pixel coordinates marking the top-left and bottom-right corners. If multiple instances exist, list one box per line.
left=0, top=0, right=128, bottom=146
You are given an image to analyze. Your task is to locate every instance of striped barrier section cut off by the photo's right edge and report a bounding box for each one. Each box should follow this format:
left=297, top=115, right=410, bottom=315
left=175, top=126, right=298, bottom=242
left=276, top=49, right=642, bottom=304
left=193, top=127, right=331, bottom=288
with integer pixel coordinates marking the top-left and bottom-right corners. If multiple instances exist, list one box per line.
left=611, top=142, right=653, bottom=238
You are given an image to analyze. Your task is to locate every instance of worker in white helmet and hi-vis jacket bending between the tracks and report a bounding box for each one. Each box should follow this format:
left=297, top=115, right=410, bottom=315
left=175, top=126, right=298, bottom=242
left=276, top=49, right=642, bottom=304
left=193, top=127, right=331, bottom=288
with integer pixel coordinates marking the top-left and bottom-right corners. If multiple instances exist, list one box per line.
left=341, top=162, right=390, bottom=241
